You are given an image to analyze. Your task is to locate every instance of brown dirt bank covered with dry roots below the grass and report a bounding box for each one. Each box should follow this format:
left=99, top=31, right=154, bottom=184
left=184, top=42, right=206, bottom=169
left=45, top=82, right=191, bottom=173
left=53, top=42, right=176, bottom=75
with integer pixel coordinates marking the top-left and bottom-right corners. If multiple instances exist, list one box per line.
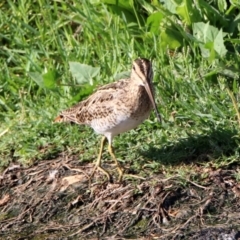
left=0, top=153, right=240, bottom=240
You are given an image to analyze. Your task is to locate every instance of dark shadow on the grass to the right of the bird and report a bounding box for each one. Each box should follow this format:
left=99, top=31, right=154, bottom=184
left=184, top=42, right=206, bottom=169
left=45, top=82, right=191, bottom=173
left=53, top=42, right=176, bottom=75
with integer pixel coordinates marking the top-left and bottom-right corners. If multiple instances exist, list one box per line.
left=141, top=126, right=240, bottom=165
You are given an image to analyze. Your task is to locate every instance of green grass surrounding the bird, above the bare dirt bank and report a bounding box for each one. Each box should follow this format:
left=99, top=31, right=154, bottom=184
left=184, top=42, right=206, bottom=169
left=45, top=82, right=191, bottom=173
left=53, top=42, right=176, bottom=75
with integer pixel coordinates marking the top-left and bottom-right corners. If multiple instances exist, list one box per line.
left=0, top=0, right=240, bottom=178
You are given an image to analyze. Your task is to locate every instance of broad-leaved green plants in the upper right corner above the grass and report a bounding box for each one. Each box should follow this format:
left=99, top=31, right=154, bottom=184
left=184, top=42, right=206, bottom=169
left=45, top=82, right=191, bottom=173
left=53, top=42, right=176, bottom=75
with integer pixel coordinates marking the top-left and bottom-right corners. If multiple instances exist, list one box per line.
left=95, top=0, right=240, bottom=62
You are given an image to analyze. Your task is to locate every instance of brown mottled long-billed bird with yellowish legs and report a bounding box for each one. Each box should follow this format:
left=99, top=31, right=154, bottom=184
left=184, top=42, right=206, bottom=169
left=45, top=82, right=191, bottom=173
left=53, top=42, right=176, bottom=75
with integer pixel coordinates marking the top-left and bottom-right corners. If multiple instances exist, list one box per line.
left=54, top=58, right=161, bottom=182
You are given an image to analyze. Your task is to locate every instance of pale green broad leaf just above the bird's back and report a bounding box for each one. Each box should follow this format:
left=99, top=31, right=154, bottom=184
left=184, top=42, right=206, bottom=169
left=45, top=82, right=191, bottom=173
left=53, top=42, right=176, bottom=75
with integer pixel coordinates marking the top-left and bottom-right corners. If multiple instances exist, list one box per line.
left=69, top=62, right=100, bottom=85
